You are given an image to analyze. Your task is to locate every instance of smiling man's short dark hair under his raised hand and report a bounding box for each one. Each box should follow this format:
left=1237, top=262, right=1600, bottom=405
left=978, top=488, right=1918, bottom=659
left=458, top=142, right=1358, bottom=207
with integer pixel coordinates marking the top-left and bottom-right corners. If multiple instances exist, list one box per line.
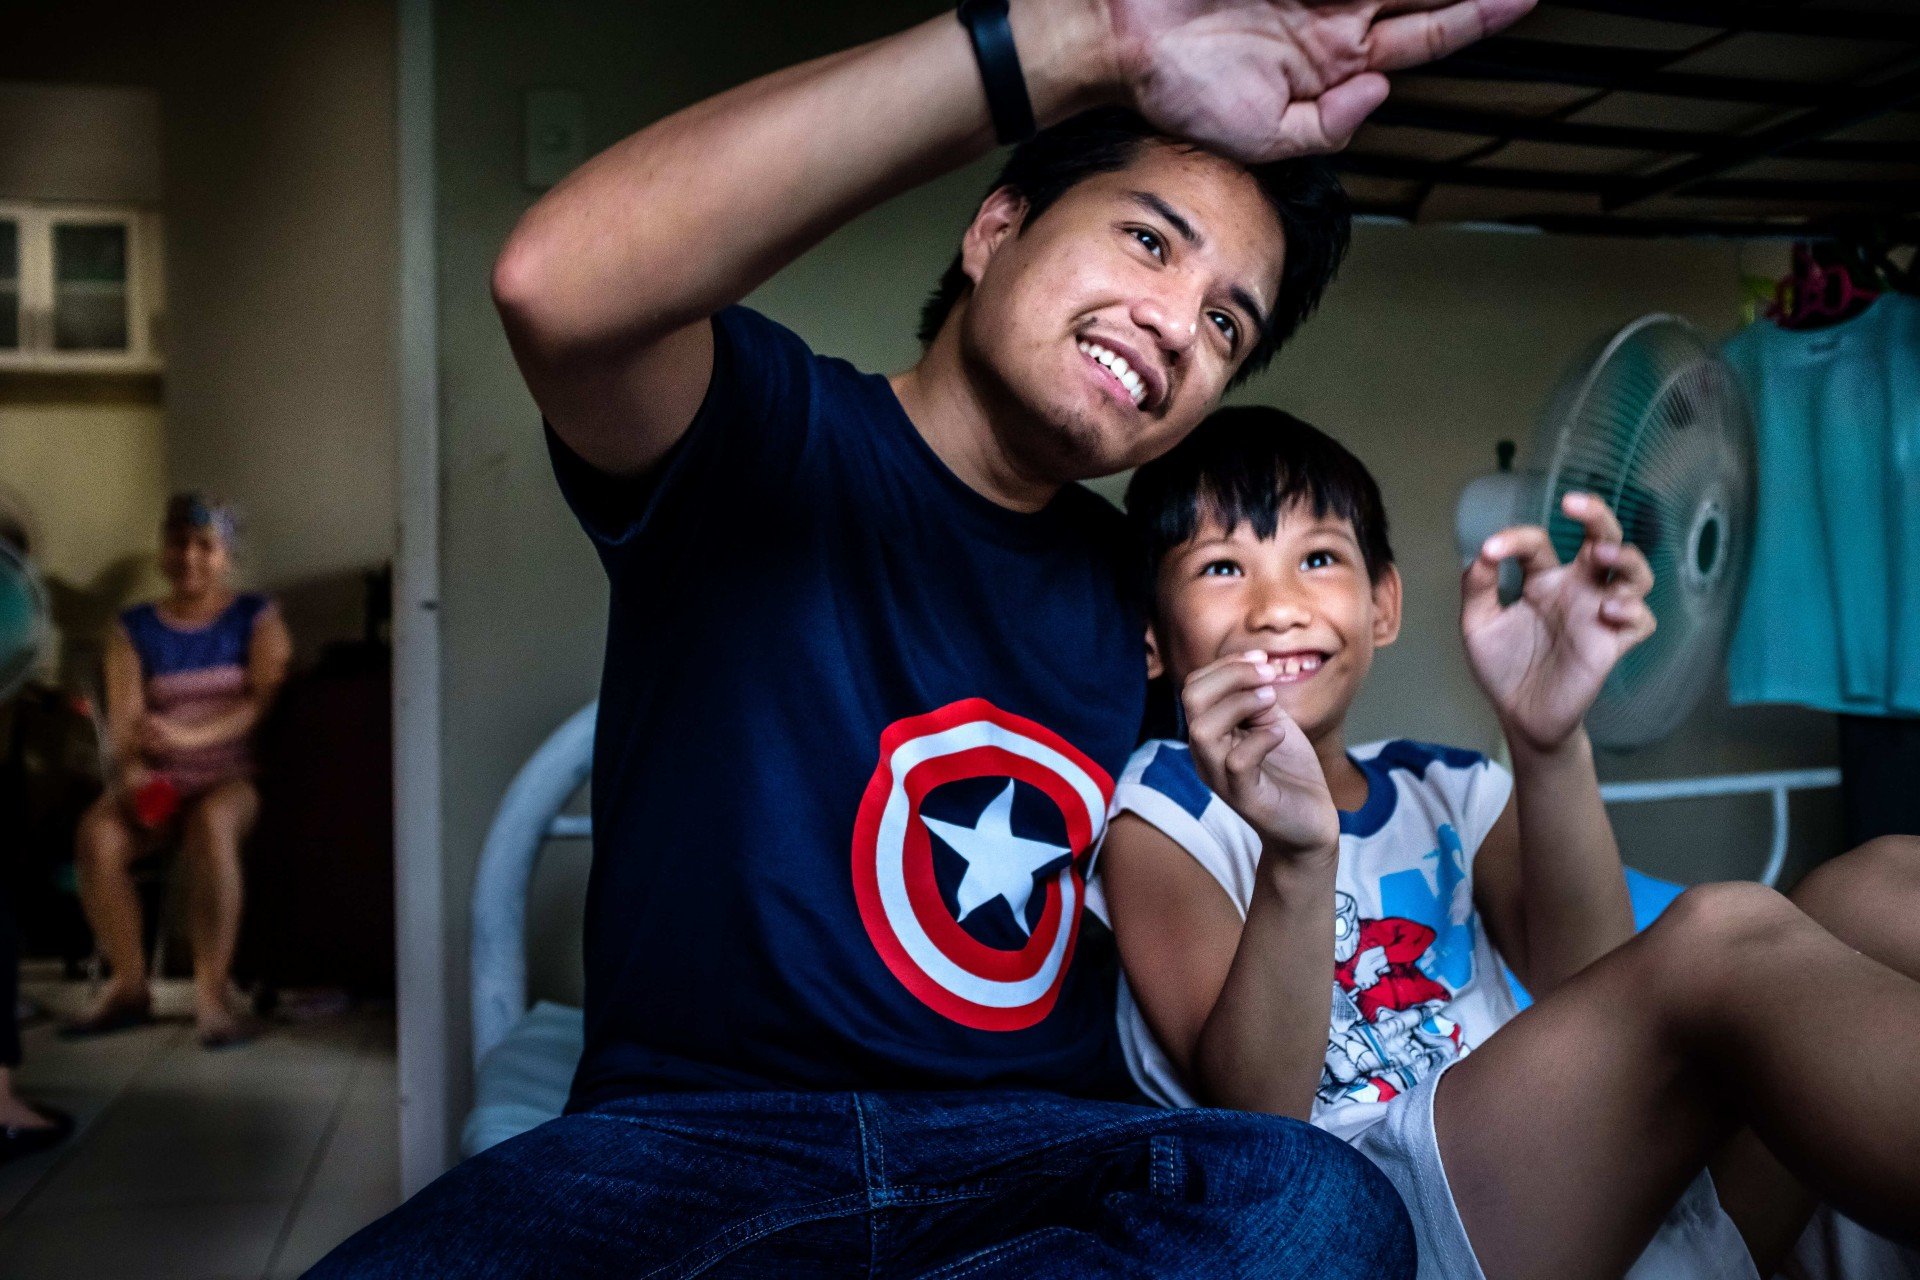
left=920, top=107, right=1352, bottom=386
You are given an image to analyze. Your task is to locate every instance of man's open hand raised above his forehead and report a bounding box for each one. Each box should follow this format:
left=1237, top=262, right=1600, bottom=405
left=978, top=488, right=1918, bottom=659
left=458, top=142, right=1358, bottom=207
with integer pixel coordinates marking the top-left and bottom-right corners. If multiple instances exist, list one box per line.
left=1106, top=0, right=1534, bottom=163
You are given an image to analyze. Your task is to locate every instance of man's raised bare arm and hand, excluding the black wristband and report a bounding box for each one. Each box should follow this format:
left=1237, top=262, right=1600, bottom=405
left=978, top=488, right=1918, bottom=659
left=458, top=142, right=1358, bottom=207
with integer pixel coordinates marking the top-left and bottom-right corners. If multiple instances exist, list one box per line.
left=493, top=0, right=1534, bottom=474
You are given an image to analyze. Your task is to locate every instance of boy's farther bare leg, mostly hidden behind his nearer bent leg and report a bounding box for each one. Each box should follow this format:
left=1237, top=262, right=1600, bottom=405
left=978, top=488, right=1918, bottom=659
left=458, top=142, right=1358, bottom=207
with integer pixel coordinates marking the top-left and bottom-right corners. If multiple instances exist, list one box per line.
left=1713, top=835, right=1920, bottom=1276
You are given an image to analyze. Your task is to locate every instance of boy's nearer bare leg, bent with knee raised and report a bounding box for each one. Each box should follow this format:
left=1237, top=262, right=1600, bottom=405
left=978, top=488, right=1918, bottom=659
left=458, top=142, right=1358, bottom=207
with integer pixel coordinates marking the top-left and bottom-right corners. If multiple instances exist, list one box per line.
left=1434, top=885, right=1920, bottom=1280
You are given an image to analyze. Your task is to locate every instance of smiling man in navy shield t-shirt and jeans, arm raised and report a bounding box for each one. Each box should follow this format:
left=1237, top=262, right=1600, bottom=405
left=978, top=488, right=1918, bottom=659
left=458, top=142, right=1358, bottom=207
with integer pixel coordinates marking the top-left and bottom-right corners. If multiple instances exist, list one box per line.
left=317, top=0, right=1532, bottom=1278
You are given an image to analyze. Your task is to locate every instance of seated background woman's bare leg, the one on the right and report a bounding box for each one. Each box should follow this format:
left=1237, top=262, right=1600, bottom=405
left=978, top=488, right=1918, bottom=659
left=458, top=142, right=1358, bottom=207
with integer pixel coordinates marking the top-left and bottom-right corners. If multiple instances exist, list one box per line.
left=182, top=779, right=259, bottom=1044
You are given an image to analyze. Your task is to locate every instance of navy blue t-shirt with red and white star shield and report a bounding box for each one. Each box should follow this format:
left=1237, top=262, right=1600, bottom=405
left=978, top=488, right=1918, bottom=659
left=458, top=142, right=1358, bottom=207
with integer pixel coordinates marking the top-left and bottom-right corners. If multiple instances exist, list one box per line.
left=549, top=307, right=1144, bottom=1109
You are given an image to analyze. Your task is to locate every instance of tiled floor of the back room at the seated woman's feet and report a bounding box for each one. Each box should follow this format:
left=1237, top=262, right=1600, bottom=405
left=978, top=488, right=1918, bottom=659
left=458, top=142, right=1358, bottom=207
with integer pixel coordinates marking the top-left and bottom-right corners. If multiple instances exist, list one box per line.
left=0, top=981, right=399, bottom=1280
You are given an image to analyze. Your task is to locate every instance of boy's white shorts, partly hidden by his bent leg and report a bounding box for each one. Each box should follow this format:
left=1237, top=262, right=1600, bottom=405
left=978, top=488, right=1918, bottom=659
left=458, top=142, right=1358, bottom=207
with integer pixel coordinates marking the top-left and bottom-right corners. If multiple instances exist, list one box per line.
left=1354, top=1059, right=1761, bottom=1280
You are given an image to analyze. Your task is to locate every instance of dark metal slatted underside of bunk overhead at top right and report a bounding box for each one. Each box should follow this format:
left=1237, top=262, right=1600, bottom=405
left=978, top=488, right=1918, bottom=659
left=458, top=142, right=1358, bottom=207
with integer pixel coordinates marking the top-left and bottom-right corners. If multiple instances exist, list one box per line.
left=1334, top=0, right=1920, bottom=240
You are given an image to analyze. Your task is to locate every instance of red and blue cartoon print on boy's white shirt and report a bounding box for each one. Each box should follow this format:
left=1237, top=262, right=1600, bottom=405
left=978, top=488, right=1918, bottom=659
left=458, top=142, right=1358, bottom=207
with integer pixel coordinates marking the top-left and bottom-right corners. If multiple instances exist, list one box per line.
left=1319, top=823, right=1473, bottom=1103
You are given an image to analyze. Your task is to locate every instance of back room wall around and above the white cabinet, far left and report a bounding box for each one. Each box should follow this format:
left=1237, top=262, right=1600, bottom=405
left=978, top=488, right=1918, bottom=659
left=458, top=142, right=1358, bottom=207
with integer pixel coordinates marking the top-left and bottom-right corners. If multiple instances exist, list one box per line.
left=0, top=0, right=396, bottom=654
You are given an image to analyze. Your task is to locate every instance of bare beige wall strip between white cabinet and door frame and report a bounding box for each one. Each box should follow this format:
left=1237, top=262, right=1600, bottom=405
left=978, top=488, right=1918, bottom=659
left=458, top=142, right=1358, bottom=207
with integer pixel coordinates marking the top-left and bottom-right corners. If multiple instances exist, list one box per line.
left=163, top=0, right=397, bottom=652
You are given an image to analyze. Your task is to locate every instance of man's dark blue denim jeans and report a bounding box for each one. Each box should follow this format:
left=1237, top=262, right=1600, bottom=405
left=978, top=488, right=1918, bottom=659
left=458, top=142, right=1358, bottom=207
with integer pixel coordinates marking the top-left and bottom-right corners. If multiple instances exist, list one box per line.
left=309, top=1092, right=1413, bottom=1280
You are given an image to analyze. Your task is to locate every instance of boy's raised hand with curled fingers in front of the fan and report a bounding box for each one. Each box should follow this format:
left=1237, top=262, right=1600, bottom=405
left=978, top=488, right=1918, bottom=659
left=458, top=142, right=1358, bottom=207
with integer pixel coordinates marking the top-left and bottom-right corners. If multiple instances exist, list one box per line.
left=1459, top=493, right=1655, bottom=750
